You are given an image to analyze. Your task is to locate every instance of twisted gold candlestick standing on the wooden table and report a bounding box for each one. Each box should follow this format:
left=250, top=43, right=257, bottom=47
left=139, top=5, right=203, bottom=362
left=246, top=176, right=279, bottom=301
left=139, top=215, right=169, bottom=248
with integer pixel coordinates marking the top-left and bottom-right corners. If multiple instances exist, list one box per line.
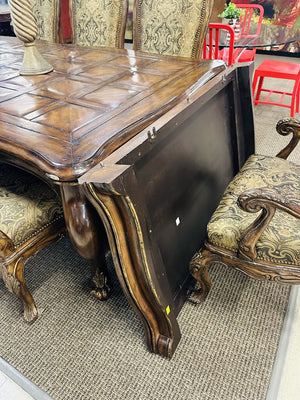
left=8, top=0, right=53, bottom=75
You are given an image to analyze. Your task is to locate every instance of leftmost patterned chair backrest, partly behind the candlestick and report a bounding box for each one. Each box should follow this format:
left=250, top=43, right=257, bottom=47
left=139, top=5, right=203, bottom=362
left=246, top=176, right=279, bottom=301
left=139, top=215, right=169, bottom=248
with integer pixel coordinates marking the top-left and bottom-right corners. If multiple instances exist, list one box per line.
left=31, top=0, right=61, bottom=42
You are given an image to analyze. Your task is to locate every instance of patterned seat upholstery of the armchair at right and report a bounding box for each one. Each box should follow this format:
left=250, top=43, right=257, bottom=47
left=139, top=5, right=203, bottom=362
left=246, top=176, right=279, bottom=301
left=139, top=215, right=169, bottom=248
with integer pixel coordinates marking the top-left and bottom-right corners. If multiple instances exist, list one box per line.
left=207, top=155, right=300, bottom=266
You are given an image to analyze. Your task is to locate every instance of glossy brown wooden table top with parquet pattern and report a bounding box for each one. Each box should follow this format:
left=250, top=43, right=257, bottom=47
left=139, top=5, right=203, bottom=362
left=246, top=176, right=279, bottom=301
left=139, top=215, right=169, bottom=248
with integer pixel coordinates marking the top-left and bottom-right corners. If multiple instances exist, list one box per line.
left=0, top=37, right=224, bottom=182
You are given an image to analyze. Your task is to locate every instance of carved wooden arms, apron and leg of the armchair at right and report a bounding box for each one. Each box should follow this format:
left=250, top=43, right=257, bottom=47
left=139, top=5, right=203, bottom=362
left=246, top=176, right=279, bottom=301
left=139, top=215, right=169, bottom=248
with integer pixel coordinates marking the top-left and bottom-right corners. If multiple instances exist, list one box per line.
left=190, top=118, right=300, bottom=303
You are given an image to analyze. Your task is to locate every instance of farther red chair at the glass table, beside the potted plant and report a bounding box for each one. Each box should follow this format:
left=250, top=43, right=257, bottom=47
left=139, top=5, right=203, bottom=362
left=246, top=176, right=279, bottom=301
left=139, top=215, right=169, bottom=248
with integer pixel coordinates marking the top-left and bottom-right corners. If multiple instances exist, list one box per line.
left=233, top=1, right=264, bottom=62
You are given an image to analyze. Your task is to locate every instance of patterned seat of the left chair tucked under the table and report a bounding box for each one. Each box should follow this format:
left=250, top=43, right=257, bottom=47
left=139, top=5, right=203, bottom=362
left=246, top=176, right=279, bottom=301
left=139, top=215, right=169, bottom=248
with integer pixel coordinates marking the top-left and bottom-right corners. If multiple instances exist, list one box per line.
left=0, top=164, right=63, bottom=248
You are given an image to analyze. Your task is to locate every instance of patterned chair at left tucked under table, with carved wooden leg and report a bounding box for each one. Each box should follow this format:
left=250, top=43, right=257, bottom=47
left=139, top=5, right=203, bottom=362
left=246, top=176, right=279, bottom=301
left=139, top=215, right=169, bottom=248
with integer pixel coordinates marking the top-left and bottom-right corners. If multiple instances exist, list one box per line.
left=0, top=164, right=65, bottom=322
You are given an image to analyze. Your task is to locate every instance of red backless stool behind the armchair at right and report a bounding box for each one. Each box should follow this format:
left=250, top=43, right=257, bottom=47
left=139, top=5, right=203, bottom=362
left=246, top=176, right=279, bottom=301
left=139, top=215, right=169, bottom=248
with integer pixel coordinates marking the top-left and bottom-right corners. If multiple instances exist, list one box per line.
left=252, top=60, right=300, bottom=117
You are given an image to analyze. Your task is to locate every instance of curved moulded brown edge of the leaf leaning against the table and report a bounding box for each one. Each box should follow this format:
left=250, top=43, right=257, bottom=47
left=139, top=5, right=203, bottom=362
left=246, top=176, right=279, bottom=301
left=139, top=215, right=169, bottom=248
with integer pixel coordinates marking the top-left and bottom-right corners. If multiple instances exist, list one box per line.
left=85, top=185, right=181, bottom=357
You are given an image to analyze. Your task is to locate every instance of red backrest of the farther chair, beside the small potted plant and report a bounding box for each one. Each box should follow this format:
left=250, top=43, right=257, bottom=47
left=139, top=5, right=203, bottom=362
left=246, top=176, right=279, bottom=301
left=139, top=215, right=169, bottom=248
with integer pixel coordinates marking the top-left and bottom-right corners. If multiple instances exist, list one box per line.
left=237, top=4, right=264, bottom=37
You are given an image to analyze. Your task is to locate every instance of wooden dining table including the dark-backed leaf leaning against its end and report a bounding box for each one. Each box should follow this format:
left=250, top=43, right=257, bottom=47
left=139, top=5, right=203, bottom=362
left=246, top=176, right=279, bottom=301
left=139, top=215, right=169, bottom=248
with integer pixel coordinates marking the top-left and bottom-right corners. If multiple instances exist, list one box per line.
left=0, top=37, right=254, bottom=357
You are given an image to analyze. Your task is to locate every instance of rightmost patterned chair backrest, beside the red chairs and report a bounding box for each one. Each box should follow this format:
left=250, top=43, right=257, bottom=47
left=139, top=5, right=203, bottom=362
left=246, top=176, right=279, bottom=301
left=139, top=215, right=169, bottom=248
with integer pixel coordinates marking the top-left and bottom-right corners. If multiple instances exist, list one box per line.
left=133, top=0, right=213, bottom=58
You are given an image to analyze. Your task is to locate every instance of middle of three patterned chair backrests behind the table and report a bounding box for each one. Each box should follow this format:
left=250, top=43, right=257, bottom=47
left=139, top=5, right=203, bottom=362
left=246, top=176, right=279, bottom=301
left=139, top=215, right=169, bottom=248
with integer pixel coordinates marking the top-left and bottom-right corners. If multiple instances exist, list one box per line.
left=70, top=0, right=128, bottom=48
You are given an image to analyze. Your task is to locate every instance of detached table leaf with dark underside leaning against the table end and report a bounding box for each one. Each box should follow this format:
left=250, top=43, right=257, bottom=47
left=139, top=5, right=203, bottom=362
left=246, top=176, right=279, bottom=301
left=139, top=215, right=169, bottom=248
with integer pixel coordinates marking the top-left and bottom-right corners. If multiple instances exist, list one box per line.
left=80, top=67, right=254, bottom=357
